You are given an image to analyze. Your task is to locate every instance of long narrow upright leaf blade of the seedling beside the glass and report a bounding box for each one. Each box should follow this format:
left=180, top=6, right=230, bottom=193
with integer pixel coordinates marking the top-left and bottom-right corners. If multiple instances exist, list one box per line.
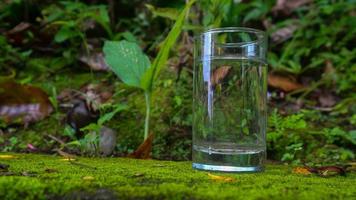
left=141, top=0, right=195, bottom=91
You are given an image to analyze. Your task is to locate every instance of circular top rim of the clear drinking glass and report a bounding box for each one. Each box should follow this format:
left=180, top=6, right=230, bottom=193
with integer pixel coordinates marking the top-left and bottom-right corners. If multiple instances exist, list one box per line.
left=193, top=27, right=266, bottom=44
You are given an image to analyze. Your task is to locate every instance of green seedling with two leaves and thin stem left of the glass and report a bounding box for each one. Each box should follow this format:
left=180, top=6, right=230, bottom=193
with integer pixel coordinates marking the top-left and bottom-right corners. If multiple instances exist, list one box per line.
left=104, top=0, right=194, bottom=139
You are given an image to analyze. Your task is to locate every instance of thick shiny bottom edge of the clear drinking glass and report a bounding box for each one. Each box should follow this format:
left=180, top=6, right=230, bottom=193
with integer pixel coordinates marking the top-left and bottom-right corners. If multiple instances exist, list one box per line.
left=193, top=163, right=264, bottom=172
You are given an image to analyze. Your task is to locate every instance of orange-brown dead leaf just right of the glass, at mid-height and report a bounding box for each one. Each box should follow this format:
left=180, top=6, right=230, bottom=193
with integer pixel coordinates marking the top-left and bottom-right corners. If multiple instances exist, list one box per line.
left=268, top=74, right=303, bottom=92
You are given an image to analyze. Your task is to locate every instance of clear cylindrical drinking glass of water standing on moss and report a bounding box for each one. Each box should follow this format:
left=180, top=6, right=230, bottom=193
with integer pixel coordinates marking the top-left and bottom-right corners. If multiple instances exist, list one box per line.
left=193, top=28, right=267, bottom=172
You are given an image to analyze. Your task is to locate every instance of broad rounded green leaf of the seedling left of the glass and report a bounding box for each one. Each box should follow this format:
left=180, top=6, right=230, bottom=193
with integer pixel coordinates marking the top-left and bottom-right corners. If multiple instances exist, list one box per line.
left=104, top=41, right=150, bottom=89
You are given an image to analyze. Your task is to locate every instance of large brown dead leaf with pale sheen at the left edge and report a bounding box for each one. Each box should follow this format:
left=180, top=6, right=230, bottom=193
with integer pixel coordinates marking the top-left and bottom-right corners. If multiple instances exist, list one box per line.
left=0, top=81, right=53, bottom=125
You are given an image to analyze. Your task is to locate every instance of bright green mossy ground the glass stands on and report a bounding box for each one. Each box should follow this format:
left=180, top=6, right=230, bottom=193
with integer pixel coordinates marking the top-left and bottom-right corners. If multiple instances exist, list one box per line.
left=0, top=153, right=356, bottom=199
